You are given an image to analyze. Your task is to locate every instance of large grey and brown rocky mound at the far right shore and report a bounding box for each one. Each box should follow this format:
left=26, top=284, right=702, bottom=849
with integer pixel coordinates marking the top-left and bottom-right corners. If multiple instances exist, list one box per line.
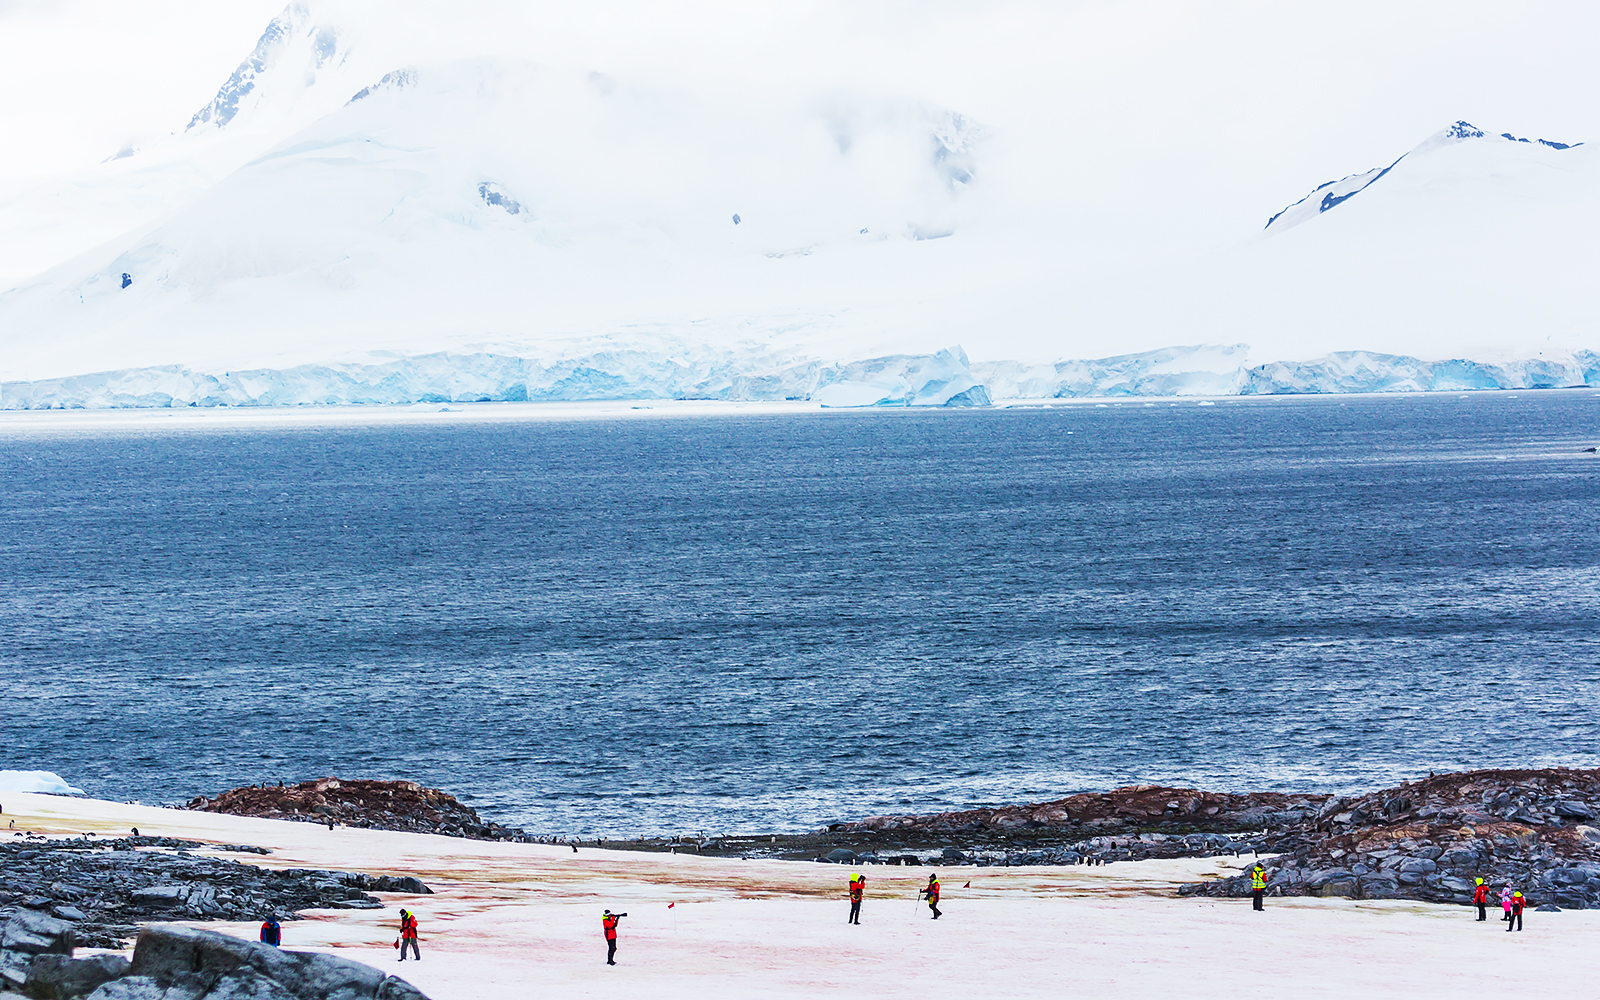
left=1181, top=768, right=1600, bottom=909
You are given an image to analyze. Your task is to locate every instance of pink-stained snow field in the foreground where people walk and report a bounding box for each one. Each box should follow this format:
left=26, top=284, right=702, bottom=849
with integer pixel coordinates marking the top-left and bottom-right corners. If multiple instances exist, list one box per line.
left=0, top=794, right=1600, bottom=1000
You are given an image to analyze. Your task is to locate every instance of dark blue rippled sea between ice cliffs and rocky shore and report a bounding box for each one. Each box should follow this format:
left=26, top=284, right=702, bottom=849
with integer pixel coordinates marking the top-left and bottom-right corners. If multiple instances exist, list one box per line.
left=0, top=390, right=1600, bottom=835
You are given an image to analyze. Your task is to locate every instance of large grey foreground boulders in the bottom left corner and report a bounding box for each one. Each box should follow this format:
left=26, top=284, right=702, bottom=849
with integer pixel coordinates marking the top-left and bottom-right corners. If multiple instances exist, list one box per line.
left=0, top=910, right=427, bottom=1000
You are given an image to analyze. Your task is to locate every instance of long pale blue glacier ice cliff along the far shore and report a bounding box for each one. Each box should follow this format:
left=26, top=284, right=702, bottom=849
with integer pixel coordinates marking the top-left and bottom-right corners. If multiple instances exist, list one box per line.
left=0, top=344, right=1600, bottom=410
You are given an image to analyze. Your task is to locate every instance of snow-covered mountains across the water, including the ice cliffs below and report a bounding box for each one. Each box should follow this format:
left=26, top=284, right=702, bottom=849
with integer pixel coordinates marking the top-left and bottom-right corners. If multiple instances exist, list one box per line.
left=0, top=3, right=1600, bottom=408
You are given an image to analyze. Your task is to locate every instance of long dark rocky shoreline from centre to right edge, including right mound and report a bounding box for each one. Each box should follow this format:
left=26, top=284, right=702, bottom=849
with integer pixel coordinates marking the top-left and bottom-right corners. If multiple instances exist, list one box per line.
left=605, top=768, right=1600, bottom=909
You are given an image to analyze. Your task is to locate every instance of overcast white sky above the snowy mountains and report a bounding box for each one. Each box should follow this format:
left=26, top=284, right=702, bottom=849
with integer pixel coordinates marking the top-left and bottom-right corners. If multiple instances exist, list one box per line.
left=0, top=0, right=1600, bottom=203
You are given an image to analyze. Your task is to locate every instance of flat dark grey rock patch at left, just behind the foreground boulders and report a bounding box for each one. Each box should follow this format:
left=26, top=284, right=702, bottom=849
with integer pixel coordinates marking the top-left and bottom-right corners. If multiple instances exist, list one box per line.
left=0, top=837, right=430, bottom=949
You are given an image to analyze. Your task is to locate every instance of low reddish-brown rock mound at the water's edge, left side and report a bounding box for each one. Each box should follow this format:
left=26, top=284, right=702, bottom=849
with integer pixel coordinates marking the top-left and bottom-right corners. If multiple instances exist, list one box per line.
left=186, top=778, right=531, bottom=842
